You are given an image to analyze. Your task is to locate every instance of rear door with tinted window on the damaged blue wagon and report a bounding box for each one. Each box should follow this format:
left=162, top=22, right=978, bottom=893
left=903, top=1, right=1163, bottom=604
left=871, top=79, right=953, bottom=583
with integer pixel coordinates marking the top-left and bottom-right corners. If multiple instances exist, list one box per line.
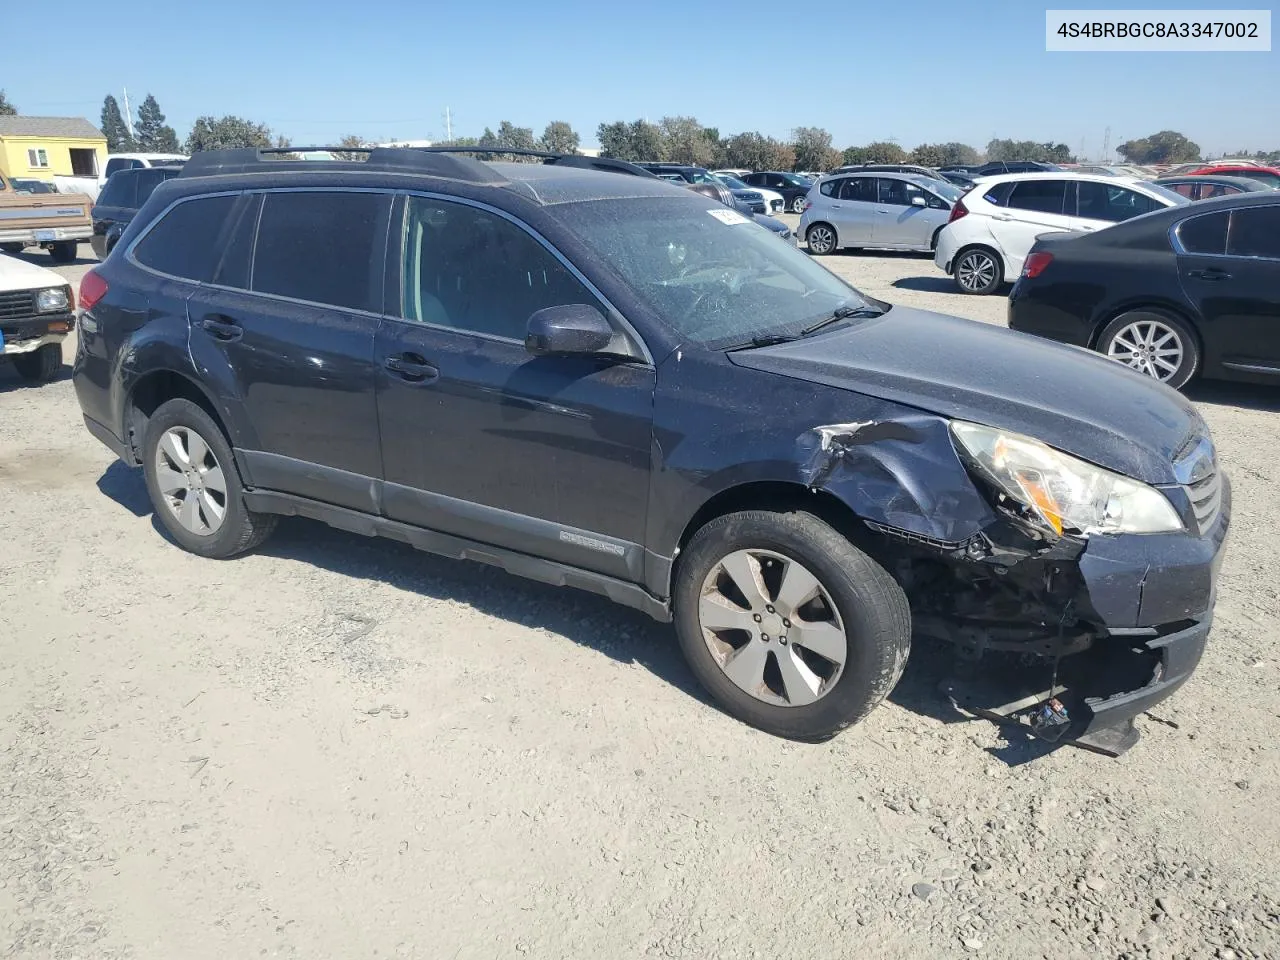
left=187, top=189, right=392, bottom=512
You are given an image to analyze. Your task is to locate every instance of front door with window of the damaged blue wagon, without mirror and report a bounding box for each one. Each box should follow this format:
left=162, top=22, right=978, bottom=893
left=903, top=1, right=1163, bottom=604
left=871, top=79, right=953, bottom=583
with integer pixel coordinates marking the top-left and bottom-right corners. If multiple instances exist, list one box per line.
left=376, top=197, right=654, bottom=581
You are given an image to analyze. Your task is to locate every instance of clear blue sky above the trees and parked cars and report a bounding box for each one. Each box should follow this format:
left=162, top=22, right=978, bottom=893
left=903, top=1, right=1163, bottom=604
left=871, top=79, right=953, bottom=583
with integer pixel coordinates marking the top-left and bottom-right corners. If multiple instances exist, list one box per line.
left=0, top=0, right=1280, bottom=157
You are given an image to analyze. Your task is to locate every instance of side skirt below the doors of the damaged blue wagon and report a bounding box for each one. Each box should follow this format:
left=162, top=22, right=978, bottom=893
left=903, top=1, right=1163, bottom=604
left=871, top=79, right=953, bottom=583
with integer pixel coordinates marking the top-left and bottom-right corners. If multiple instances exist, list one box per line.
left=244, top=490, right=671, bottom=622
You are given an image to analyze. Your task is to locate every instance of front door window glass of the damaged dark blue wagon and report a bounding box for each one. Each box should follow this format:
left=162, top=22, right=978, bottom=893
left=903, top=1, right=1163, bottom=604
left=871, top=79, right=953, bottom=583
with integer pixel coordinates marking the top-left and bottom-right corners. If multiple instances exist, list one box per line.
left=402, top=197, right=604, bottom=340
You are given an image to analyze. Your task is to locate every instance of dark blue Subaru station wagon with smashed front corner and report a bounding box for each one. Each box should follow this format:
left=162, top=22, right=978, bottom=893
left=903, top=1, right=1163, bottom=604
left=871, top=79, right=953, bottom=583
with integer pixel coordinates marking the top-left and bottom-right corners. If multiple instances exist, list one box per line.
left=74, top=150, right=1230, bottom=744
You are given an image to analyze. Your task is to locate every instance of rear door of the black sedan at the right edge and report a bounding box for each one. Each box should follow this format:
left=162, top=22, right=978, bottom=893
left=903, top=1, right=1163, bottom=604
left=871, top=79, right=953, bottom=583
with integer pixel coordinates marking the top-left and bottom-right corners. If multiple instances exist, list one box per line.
left=1176, top=204, right=1280, bottom=378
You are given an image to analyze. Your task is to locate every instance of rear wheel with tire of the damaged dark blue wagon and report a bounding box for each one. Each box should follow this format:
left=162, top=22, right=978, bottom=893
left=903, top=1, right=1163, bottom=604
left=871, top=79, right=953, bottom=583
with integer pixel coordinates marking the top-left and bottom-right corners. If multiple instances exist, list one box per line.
left=142, top=399, right=276, bottom=559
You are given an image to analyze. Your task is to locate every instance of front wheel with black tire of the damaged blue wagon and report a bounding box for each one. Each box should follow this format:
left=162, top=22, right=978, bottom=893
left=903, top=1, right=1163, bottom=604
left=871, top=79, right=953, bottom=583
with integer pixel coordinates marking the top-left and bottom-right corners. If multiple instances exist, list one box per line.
left=673, top=511, right=911, bottom=741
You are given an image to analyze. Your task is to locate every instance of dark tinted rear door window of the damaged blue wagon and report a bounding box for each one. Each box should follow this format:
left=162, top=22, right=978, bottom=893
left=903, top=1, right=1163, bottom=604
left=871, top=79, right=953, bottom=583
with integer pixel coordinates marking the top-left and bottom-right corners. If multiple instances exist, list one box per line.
left=253, top=191, right=390, bottom=314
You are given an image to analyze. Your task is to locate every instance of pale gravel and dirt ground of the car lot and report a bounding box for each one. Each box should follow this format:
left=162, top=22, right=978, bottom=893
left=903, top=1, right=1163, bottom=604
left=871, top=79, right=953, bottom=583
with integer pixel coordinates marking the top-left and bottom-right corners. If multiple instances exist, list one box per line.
left=0, top=235, right=1280, bottom=960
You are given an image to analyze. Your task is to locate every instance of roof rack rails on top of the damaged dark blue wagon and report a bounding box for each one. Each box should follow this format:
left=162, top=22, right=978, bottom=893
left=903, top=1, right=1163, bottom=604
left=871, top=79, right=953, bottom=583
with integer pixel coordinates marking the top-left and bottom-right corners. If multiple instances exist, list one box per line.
left=182, top=146, right=654, bottom=183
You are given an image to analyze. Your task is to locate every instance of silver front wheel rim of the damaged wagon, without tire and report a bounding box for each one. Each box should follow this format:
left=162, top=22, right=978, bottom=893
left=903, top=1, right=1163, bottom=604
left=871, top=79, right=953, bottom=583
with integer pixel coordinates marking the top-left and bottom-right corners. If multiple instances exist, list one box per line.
left=698, top=549, right=849, bottom=707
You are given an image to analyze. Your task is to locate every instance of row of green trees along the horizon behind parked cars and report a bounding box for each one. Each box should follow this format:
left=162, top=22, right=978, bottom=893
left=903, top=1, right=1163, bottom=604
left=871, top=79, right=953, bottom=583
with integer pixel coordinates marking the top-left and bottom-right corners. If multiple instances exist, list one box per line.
left=0, top=90, right=1280, bottom=170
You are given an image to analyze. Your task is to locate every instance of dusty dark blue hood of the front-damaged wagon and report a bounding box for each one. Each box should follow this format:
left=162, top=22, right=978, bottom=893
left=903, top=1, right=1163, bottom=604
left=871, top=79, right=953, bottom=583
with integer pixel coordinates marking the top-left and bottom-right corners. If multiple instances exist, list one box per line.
left=730, top=307, right=1207, bottom=484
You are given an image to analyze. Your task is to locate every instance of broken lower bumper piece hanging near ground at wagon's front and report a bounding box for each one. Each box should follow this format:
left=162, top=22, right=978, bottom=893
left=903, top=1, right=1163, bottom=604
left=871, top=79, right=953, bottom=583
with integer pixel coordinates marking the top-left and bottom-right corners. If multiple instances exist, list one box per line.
left=941, top=613, right=1213, bottom=756
